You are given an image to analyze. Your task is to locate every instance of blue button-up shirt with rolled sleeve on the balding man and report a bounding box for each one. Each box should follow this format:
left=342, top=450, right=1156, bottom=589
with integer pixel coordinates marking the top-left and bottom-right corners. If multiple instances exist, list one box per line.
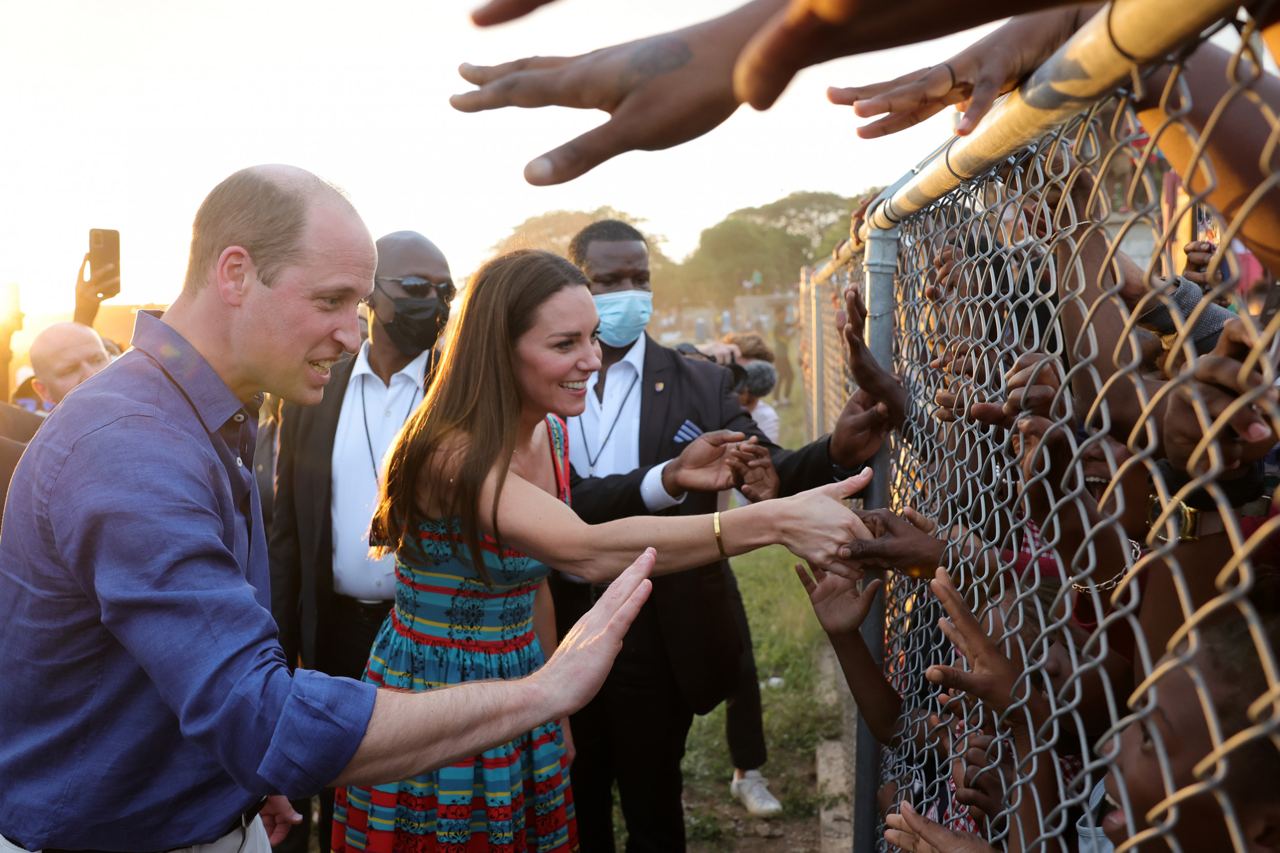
left=0, top=314, right=376, bottom=850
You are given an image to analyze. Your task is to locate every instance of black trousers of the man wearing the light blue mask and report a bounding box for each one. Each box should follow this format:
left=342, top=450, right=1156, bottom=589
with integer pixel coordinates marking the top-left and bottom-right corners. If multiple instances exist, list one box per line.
left=552, top=578, right=694, bottom=853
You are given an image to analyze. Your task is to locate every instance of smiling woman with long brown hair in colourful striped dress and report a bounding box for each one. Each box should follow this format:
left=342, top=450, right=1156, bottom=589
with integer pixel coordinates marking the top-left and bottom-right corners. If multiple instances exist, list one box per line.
left=333, top=251, right=869, bottom=853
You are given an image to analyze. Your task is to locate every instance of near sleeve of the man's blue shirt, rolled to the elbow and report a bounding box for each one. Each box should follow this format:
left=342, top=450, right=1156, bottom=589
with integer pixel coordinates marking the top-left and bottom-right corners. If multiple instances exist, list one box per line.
left=46, top=416, right=376, bottom=797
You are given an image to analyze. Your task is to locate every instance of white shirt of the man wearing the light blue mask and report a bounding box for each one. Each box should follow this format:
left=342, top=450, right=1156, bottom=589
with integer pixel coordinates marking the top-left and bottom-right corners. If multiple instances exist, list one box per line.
left=568, top=334, right=685, bottom=512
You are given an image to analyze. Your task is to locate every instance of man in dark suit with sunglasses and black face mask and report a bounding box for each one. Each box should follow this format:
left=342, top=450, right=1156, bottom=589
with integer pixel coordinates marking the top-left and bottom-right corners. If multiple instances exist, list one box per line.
left=269, top=232, right=454, bottom=850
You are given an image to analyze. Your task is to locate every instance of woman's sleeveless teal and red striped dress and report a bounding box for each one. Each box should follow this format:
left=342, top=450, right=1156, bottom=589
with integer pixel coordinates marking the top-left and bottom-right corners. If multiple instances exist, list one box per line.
left=333, top=418, right=577, bottom=853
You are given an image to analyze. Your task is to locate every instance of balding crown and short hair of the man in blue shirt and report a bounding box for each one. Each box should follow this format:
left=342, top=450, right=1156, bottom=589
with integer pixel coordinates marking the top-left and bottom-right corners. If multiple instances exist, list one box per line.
left=183, top=165, right=358, bottom=293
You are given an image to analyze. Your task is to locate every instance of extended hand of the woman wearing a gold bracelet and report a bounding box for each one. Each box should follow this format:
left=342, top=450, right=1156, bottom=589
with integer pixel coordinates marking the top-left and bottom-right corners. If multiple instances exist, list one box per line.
left=769, top=467, right=872, bottom=578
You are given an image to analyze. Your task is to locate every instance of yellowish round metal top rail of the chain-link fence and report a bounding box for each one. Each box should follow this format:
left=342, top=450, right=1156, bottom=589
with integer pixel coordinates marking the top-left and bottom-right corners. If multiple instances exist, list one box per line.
left=849, top=0, right=1239, bottom=236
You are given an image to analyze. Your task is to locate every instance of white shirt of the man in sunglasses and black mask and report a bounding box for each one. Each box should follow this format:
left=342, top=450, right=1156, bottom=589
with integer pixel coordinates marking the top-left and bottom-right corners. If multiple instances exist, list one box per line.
left=330, top=341, right=430, bottom=602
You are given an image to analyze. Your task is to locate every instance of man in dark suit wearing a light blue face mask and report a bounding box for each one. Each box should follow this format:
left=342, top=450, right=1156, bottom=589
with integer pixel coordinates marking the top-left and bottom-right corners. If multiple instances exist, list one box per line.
left=552, top=220, right=900, bottom=853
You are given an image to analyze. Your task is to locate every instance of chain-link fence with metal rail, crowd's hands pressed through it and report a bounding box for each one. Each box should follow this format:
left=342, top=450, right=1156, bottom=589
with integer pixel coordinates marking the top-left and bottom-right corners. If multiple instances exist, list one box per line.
left=800, top=0, right=1280, bottom=852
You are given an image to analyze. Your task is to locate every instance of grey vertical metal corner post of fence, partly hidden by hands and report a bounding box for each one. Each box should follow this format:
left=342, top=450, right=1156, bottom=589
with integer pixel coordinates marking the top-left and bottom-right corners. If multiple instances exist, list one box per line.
left=852, top=222, right=899, bottom=853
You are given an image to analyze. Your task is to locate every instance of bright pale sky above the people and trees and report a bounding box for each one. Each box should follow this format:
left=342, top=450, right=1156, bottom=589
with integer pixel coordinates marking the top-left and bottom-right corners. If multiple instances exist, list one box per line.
left=0, top=0, right=993, bottom=350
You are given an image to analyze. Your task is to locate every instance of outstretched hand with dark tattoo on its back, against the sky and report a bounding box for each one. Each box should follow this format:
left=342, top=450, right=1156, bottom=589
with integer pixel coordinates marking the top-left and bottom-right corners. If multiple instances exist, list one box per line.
left=449, top=0, right=772, bottom=186
